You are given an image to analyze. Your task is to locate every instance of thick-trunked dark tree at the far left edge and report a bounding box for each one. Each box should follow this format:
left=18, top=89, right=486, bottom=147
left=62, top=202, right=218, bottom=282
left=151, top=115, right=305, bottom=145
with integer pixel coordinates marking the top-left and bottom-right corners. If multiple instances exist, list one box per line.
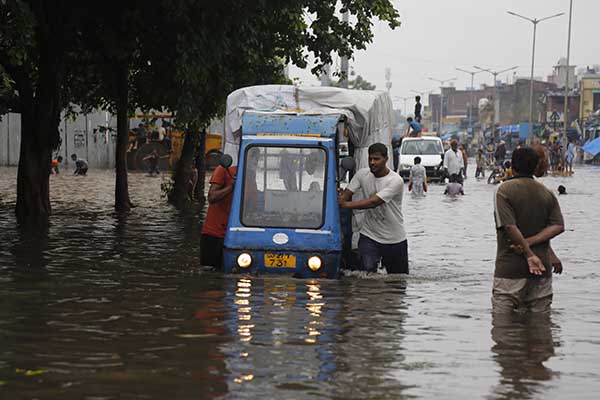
left=0, top=0, right=85, bottom=226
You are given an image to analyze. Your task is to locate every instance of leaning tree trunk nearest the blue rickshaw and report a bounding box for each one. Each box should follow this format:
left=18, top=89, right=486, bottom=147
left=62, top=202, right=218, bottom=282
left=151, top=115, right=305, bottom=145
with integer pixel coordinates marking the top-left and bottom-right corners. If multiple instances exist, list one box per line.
left=169, top=128, right=200, bottom=208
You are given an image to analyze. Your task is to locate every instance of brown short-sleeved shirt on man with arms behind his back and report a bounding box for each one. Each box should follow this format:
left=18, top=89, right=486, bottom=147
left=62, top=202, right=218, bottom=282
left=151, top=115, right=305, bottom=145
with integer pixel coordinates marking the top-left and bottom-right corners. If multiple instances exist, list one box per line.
left=494, top=176, right=564, bottom=279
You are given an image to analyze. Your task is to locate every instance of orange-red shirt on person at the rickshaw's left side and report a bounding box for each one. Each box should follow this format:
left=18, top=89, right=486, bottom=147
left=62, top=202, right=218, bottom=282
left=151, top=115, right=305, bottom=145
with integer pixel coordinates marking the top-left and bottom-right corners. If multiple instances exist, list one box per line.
left=202, top=166, right=237, bottom=238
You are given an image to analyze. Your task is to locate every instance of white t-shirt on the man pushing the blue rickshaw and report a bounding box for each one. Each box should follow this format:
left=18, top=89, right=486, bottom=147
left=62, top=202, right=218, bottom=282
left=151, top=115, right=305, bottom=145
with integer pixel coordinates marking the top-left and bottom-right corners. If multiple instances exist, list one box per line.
left=347, top=168, right=406, bottom=244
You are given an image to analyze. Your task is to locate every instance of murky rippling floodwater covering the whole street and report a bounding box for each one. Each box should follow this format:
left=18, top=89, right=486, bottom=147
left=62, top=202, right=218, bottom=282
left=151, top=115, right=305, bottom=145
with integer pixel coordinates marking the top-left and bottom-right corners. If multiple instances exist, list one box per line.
left=0, top=167, right=600, bottom=400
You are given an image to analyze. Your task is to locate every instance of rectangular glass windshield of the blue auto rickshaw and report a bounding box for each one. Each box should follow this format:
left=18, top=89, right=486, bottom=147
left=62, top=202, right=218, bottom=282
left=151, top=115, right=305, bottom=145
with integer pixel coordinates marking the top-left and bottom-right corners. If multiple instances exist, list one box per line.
left=241, top=146, right=327, bottom=229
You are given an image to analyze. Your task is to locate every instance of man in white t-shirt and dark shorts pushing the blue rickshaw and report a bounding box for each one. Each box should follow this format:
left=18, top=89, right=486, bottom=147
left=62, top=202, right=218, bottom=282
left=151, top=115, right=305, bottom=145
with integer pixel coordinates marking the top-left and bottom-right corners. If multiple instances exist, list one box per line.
left=338, top=143, right=408, bottom=274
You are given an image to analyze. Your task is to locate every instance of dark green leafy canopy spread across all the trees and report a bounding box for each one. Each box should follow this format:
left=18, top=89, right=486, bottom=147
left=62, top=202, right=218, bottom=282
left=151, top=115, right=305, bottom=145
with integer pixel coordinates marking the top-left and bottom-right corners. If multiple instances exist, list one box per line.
left=0, top=0, right=400, bottom=136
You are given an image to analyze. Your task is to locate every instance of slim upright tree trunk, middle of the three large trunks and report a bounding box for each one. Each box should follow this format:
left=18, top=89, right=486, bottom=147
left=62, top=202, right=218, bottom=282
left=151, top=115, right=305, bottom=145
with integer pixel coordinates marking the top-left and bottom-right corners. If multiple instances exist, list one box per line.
left=115, top=65, right=131, bottom=212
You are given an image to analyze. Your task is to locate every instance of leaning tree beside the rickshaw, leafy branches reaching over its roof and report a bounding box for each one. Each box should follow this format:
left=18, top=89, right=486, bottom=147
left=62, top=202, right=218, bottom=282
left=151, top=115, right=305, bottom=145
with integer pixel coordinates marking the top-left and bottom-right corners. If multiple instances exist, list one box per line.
left=159, top=0, right=399, bottom=205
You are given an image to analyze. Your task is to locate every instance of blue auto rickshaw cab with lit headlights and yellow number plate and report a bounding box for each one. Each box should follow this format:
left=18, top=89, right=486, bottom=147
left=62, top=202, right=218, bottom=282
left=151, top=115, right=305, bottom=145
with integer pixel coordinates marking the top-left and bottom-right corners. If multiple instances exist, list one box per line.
left=223, top=111, right=353, bottom=278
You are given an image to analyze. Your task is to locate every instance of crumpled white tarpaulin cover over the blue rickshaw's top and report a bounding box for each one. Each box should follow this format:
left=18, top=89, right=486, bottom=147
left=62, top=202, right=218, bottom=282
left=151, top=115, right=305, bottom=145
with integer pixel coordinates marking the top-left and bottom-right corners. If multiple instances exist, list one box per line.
left=224, top=85, right=393, bottom=169
